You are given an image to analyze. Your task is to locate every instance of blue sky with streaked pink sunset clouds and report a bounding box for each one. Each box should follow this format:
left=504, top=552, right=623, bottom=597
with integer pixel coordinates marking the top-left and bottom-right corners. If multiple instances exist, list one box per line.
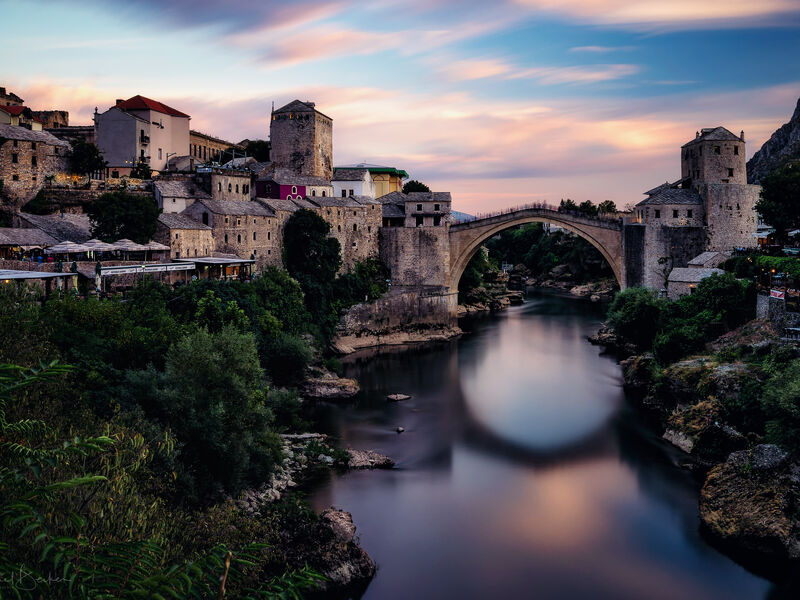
left=0, top=0, right=800, bottom=213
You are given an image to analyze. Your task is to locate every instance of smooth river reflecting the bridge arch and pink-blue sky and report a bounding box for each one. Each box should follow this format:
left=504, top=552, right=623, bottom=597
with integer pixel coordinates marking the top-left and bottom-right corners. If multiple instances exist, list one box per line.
left=310, top=295, right=770, bottom=600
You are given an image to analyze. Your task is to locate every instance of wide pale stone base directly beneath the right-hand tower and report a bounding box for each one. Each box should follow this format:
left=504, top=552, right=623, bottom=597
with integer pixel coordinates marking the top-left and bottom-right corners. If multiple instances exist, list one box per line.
left=701, top=183, right=761, bottom=252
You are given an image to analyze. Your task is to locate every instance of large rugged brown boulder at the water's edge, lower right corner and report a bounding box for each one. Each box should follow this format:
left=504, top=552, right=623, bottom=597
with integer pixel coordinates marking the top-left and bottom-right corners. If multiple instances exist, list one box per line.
left=700, top=444, right=800, bottom=559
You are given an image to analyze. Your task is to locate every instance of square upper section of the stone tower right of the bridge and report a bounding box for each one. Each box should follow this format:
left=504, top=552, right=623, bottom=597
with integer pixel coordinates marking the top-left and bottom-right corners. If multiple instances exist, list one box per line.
left=681, top=127, right=747, bottom=189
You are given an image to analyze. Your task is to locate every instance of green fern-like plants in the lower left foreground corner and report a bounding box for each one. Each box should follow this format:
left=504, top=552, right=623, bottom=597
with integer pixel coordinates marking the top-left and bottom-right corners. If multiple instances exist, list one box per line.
left=0, top=363, right=323, bottom=600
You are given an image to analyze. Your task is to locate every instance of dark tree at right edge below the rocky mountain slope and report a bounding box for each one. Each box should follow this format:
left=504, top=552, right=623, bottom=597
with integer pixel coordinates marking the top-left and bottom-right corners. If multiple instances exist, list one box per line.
left=756, top=163, right=800, bottom=242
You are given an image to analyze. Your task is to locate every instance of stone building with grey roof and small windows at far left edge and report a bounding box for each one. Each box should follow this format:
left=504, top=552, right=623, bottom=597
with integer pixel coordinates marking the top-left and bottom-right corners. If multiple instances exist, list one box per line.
left=0, top=125, right=69, bottom=206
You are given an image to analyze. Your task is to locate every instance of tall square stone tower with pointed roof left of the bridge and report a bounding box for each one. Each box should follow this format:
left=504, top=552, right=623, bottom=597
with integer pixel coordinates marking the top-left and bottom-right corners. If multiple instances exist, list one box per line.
left=269, top=100, right=333, bottom=181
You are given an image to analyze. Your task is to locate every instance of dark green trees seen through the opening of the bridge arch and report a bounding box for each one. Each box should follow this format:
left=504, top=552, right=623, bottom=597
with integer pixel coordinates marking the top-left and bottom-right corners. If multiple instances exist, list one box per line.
left=486, top=223, right=614, bottom=283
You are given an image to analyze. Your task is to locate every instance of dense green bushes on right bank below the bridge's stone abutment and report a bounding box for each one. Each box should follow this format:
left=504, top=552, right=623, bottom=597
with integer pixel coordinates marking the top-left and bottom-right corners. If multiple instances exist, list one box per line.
left=608, top=273, right=755, bottom=364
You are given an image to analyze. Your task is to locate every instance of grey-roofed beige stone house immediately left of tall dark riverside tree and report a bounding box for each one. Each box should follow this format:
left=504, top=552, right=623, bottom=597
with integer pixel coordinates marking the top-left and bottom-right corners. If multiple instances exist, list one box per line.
left=180, top=200, right=281, bottom=268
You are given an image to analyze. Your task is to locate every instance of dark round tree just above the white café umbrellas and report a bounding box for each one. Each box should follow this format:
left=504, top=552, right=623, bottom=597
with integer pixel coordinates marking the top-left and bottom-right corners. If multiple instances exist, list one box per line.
left=87, top=191, right=161, bottom=244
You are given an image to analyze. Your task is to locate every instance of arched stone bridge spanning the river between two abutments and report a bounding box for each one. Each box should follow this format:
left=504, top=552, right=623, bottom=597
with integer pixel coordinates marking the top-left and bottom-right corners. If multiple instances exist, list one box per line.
left=449, top=206, right=626, bottom=290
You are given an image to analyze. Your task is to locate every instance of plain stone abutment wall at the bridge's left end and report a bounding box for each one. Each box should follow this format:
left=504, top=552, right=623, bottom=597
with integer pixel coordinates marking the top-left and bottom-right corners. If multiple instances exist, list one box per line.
left=380, top=227, right=450, bottom=287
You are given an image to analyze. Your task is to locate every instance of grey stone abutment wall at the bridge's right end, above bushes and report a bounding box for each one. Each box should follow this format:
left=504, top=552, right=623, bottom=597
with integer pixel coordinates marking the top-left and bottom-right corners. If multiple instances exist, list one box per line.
left=642, top=227, right=707, bottom=290
